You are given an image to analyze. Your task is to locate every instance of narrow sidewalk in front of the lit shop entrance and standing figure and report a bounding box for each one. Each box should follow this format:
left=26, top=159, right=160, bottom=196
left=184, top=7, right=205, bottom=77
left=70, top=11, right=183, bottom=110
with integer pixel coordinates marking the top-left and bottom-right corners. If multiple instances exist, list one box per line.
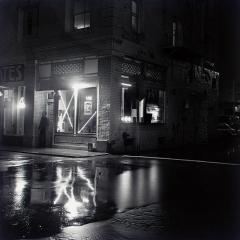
left=0, top=146, right=107, bottom=158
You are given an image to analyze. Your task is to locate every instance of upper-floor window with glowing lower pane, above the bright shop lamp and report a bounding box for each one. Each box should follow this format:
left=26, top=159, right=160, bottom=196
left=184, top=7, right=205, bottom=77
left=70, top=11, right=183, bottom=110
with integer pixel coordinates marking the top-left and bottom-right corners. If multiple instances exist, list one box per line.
left=73, top=0, right=91, bottom=29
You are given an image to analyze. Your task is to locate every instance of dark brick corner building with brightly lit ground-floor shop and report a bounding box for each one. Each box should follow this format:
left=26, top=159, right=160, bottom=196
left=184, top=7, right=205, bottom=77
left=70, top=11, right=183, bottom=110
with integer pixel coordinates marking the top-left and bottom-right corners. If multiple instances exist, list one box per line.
left=0, top=0, right=218, bottom=152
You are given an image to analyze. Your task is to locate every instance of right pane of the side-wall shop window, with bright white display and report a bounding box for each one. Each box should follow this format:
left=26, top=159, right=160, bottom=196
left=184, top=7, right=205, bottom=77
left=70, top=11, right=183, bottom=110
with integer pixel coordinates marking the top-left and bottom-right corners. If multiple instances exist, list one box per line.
left=145, top=89, right=165, bottom=123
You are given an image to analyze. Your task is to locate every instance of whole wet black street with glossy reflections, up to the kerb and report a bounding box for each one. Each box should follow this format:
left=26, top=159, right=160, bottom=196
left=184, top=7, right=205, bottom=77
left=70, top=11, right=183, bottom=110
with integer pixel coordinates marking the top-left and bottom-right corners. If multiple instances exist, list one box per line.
left=0, top=152, right=240, bottom=240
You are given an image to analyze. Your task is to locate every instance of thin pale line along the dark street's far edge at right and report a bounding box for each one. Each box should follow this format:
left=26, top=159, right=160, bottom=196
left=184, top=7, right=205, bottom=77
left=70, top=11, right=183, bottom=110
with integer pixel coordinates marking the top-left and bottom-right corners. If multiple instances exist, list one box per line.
left=122, top=155, right=240, bottom=166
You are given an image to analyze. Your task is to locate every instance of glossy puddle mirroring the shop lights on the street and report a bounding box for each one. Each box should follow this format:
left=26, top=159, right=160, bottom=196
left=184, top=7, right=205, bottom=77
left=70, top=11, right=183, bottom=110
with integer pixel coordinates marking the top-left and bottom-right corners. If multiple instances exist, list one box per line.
left=0, top=156, right=159, bottom=238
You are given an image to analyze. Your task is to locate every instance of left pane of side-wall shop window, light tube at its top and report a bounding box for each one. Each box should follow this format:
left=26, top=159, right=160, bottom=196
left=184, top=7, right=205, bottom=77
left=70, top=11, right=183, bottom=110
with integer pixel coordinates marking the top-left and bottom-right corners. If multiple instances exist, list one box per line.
left=121, top=83, right=137, bottom=123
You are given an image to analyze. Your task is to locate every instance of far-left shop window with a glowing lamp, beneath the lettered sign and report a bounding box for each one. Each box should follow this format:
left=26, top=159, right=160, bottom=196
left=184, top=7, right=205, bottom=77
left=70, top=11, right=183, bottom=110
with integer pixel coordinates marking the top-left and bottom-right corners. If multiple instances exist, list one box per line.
left=3, top=86, right=25, bottom=136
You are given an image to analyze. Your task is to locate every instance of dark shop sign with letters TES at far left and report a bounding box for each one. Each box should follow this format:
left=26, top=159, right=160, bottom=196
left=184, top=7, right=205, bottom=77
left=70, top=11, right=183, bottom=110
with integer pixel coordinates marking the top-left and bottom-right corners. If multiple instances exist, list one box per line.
left=0, top=64, right=24, bottom=82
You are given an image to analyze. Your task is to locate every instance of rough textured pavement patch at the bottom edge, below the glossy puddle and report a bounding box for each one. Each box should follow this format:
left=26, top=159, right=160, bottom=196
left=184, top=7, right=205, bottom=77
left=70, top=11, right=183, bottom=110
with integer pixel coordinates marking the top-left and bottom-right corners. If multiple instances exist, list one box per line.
left=33, top=204, right=172, bottom=240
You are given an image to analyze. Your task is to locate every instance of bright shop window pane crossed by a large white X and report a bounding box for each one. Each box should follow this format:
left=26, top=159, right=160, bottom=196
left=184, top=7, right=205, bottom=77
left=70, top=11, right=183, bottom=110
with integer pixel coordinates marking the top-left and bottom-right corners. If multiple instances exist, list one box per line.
left=57, top=90, right=74, bottom=133
